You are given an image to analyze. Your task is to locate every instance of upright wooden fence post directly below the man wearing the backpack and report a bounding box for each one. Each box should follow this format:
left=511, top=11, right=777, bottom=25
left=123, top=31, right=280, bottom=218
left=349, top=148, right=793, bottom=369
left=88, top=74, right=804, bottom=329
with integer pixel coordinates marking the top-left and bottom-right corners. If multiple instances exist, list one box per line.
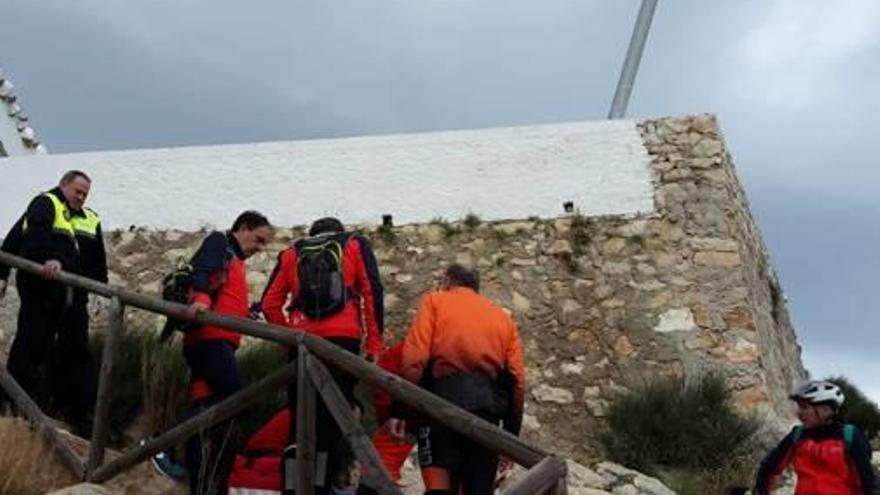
left=296, top=345, right=315, bottom=495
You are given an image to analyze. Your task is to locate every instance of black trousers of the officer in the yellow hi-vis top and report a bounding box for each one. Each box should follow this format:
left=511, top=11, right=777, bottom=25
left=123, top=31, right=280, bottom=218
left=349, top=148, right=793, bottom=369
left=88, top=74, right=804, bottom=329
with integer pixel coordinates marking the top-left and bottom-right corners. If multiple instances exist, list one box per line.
left=7, top=274, right=97, bottom=430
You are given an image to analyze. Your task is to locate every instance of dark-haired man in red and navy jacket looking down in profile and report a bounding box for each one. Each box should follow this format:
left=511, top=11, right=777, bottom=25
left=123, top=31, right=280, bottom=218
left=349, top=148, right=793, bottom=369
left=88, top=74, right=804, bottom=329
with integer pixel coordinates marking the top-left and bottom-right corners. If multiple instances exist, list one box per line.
left=183, top=211, right=274, bottom=495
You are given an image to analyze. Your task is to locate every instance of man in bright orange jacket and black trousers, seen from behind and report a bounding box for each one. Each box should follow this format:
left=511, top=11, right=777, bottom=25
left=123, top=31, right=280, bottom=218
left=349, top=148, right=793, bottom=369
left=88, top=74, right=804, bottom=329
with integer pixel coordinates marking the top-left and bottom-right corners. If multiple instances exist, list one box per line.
left=389, top=264, right=525, bottom=495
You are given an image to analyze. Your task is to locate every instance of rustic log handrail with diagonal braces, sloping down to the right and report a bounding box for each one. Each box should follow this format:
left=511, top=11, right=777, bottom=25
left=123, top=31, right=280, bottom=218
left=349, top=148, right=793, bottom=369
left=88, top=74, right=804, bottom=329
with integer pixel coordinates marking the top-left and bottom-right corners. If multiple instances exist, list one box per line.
left=0, top=251, right=566, bottom=495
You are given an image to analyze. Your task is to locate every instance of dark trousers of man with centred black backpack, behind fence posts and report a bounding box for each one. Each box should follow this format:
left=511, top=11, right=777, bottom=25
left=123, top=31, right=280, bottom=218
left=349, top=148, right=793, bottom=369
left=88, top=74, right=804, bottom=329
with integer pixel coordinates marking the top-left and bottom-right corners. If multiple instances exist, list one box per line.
left=282, top=337, right=361, bottom=495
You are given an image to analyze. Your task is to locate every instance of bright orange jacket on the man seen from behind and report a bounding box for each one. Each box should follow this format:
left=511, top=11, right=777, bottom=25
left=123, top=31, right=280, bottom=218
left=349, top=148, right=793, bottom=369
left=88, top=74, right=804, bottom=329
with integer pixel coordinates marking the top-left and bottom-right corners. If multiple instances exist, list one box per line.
left=401, top=287, right=525, bottom=434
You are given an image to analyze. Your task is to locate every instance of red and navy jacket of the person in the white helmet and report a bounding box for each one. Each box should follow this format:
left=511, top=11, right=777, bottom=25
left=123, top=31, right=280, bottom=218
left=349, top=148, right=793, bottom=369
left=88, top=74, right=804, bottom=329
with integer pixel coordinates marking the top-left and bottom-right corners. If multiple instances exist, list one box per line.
left=755, top=423, right=874, bottom=495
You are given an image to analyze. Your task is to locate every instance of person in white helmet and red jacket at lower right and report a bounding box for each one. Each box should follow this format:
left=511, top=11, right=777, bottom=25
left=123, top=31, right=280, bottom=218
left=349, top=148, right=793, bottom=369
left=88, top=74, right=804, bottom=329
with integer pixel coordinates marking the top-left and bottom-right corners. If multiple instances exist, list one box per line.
left=755, top=380, right=874, bottom=495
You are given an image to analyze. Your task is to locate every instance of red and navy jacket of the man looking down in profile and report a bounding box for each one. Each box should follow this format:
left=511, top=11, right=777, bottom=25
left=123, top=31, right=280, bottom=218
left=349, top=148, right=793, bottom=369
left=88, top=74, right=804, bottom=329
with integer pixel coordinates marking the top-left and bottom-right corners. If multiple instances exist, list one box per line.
left=183, top=232, right=249, bottom=347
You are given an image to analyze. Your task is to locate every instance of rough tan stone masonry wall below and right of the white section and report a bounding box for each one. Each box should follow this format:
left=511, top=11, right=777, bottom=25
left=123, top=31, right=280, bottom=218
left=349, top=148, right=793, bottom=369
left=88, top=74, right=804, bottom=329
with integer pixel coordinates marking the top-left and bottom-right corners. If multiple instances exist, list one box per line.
left=0, top=116, right=804, bottom=461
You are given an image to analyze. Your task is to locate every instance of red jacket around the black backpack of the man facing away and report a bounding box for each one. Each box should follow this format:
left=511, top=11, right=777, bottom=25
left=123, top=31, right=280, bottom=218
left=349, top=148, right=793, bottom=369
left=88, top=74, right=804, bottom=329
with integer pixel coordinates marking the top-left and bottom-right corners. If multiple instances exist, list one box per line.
left=262, top=234, right=384, bottom=356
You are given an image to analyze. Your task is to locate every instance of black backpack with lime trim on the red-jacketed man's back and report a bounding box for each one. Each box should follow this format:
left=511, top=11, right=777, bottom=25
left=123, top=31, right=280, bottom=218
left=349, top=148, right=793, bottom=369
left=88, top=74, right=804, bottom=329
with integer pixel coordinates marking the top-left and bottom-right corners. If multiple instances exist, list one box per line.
left=293, top=233, right=351, bottom=320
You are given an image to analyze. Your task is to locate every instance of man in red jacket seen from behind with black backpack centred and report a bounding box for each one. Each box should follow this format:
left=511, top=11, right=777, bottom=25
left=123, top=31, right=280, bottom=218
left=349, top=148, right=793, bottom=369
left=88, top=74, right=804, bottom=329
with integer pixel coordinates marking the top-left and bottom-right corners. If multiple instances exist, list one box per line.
left=262, top=217, right=384, bottom=493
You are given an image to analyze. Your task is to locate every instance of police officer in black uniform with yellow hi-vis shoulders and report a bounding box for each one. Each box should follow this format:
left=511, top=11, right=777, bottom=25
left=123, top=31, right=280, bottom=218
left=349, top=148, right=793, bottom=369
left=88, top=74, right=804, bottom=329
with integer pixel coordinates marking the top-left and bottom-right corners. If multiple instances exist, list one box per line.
left=0, top=170, right=107, bottom=433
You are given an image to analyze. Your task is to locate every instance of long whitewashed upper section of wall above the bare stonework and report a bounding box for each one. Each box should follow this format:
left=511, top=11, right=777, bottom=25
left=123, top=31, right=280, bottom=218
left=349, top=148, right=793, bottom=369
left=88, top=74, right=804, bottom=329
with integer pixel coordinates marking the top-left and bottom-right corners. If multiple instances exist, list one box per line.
left=0, top=121, right=654, bottom=231
